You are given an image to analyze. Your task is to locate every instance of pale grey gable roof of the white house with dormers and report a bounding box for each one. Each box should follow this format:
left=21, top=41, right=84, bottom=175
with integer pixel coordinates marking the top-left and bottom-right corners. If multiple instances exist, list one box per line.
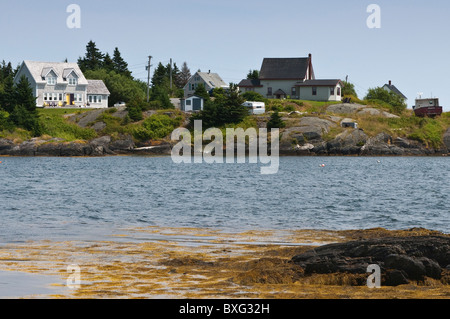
left=17, top=61, right=88, bottom=85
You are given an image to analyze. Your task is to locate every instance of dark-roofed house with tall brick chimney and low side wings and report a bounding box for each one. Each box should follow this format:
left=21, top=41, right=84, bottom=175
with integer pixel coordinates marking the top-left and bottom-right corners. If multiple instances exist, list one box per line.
left=238, top=54, right=342, bottom=101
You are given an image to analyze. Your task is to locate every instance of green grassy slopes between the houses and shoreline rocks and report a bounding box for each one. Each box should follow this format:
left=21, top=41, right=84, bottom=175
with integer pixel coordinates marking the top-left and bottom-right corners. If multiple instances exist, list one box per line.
left=0, top=99, right=450, bottom=149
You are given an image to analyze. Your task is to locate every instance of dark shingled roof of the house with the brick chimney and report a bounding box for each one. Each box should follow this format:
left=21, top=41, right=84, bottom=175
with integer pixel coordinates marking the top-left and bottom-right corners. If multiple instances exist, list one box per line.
left=259, top=58, right=309, bottom=80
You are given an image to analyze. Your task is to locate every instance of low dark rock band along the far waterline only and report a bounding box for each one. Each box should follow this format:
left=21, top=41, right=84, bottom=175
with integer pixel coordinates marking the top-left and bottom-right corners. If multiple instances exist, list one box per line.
left=0, top=129, right=450, bottom=157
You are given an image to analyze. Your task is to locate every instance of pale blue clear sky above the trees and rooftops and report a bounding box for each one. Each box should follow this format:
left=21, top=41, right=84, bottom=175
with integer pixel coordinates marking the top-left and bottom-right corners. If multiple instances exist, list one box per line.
left=0, top=0, right=450, bottom=111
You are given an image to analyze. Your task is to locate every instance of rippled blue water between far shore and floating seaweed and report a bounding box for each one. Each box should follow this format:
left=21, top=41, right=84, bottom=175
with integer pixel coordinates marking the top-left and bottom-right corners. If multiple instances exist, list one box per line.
left=0, top=157, right=450, bottom=243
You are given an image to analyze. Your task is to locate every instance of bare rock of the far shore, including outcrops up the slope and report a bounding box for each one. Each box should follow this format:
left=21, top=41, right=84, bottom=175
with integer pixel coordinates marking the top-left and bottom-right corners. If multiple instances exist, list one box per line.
left=0, top=103, right=450, bottom=157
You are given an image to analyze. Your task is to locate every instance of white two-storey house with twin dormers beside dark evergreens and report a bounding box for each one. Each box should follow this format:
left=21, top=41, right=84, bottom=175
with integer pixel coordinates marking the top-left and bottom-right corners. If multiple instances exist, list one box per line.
left=14, top=61, right=110, bottom=108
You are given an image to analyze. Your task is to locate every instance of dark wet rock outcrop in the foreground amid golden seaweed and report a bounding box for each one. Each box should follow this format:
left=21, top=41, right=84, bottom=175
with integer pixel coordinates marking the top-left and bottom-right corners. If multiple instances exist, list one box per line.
left=292, top=236, right=450, bottom=286
